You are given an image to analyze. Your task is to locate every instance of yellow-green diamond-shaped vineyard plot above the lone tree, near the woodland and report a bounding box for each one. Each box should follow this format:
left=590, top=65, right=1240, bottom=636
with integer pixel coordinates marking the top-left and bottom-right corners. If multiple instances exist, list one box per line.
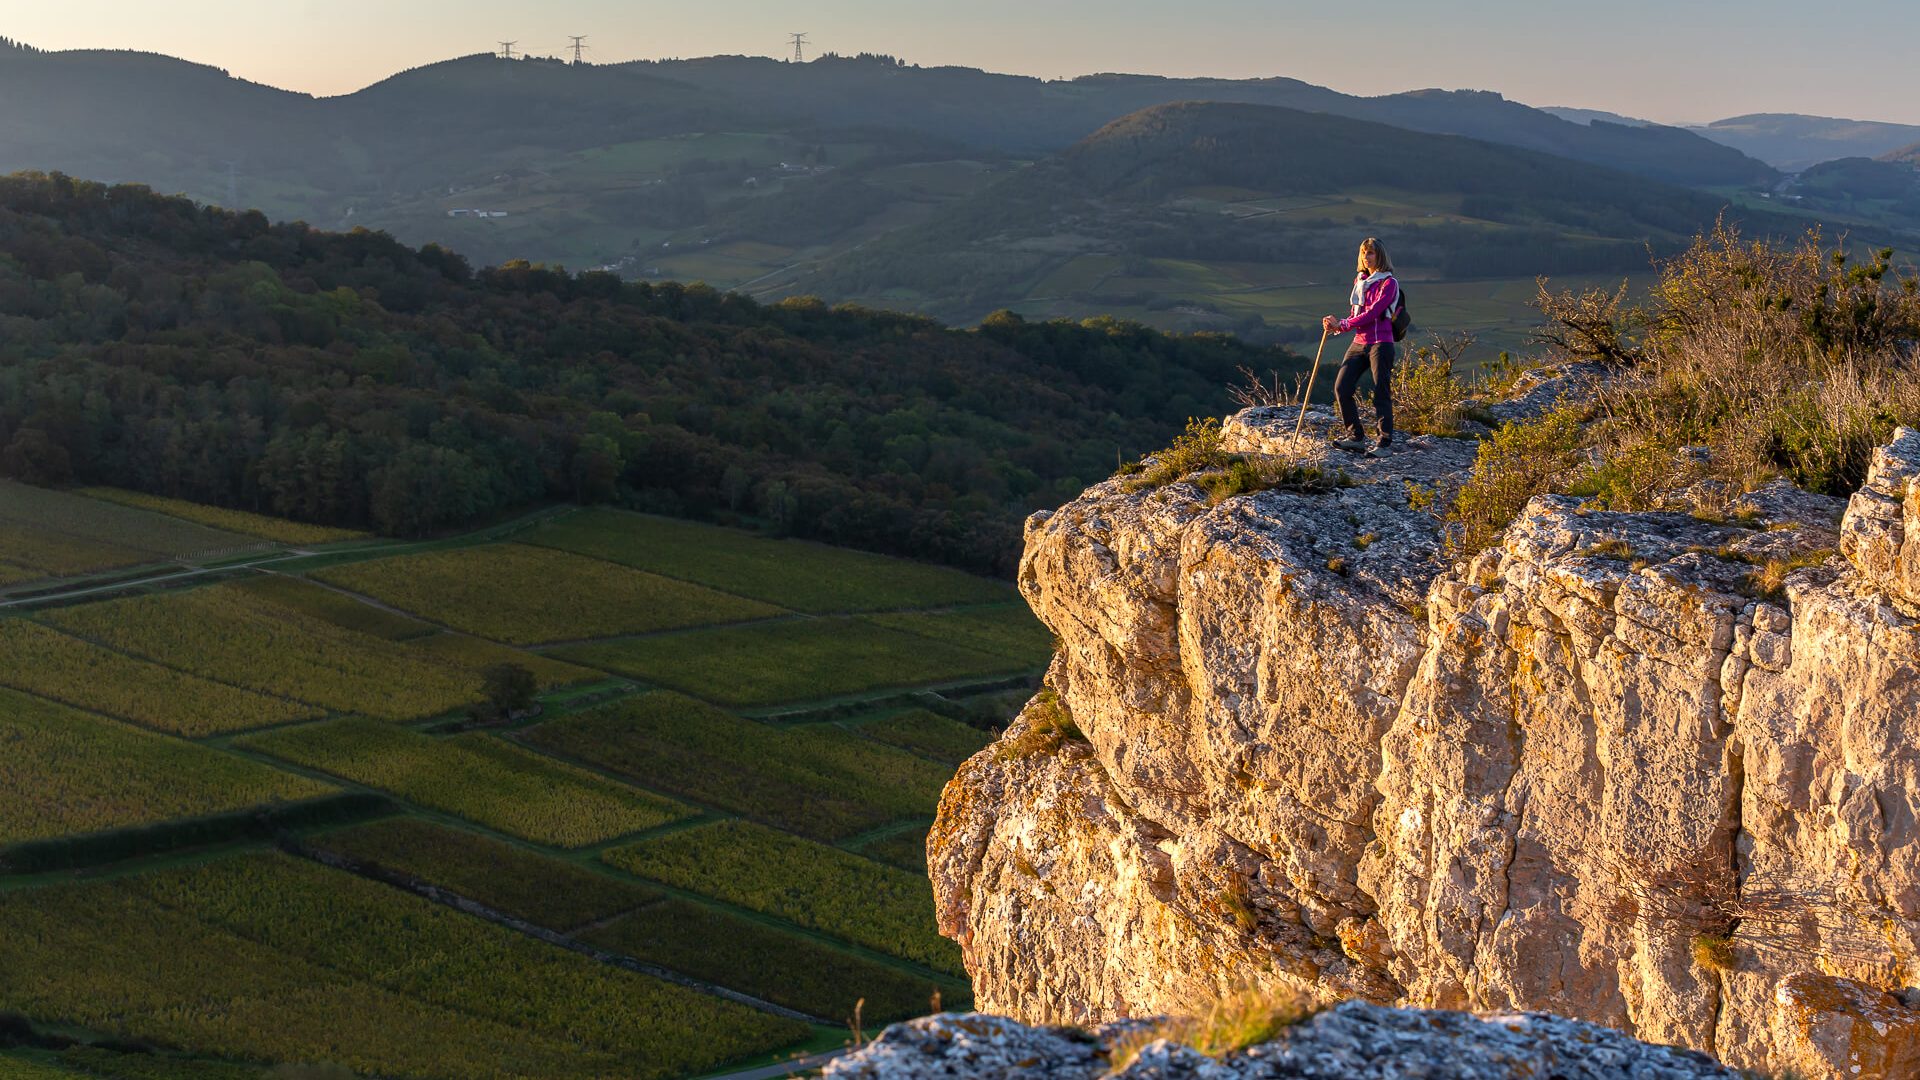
left=317, top=544, right=780, bottom=646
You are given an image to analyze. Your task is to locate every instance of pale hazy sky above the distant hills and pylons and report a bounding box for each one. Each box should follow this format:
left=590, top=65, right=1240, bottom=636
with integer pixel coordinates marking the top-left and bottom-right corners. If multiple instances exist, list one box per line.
left=15, top=0, right=1920, bottom=123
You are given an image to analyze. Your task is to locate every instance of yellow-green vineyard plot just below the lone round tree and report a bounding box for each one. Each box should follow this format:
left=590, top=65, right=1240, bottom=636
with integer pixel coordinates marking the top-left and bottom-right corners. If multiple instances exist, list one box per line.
left=240, top=719, right=689, bottom=847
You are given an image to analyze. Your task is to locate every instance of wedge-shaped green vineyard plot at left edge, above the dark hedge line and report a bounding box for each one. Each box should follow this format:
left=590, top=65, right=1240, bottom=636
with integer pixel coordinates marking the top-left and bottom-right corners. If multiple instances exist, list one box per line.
left=0, top=690, right=332, bottom=844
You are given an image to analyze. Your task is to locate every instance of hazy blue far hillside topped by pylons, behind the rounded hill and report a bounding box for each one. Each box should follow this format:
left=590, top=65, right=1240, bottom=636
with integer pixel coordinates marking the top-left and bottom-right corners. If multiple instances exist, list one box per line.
left=0, top=46, right=1778, bottom=344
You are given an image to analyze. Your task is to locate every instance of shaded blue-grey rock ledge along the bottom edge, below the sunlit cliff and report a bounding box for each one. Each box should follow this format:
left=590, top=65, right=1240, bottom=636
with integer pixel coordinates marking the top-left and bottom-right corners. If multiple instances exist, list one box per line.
left=826, top=1001, right=1736, bottom=1080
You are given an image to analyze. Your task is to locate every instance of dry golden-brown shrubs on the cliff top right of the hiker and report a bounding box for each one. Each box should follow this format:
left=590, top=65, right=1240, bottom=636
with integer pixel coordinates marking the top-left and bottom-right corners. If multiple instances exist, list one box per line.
left=1450, top=223, right=1920, bottom=553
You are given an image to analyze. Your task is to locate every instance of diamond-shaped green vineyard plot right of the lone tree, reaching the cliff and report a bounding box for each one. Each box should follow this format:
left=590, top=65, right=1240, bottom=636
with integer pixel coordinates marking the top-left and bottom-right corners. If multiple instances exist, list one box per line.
left=553, top=617, right=1044, bottom=707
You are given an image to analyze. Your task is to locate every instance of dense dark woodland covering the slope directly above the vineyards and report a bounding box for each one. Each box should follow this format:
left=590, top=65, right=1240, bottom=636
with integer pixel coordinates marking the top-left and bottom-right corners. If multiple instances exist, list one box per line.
left=0, top=175, right=1304, bottom=571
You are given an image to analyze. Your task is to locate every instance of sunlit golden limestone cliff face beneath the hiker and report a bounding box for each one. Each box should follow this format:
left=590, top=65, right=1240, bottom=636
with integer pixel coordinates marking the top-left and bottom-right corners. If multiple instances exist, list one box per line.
left=929, top=409, right=1920, bottom=1078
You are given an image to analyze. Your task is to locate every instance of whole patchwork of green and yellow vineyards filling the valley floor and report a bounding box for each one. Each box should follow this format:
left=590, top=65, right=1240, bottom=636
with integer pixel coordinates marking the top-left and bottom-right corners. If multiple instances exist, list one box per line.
left=0, top=488, right=1050, bottom=1080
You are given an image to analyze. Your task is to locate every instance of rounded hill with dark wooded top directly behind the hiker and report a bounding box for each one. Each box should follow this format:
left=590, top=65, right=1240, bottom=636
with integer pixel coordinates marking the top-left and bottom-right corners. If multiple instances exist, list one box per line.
left=791, top=102, right=1812, bottom=348
